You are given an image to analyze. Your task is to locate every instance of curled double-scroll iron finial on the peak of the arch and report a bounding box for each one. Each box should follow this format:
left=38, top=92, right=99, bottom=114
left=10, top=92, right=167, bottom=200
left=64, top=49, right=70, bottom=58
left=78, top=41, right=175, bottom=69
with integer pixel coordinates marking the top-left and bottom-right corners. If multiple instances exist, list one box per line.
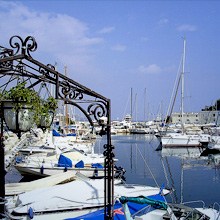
left=9, top=35, right=37, bottom=57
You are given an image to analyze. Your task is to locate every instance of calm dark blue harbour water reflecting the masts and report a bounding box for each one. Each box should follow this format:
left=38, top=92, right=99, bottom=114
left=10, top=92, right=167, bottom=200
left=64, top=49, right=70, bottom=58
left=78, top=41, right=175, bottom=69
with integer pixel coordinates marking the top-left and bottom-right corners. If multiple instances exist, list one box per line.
left=95, top=135, right=220, bottom=206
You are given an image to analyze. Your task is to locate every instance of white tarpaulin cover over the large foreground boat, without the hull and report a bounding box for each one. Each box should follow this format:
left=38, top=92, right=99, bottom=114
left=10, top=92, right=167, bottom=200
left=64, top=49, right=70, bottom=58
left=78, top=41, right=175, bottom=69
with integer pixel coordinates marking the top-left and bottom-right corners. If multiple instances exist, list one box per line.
left=8, top=179, right=169, bottom=214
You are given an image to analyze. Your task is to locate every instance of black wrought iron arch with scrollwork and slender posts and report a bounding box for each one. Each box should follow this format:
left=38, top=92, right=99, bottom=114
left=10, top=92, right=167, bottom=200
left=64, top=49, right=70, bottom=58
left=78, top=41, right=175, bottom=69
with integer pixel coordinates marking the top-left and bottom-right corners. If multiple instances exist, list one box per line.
left=0, top=35, right=114, bottom=219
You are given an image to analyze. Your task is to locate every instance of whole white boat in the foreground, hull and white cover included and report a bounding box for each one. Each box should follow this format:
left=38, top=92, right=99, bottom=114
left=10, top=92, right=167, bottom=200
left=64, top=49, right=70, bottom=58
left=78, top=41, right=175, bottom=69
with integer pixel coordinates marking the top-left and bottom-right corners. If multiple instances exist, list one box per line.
left=6, top=179, right=169, bottom=220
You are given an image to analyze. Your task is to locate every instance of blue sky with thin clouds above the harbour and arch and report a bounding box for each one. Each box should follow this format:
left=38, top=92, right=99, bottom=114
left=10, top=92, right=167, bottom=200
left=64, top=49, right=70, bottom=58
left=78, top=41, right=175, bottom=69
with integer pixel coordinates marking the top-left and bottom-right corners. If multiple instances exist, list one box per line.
left=0, top=0, right=220, bottom=120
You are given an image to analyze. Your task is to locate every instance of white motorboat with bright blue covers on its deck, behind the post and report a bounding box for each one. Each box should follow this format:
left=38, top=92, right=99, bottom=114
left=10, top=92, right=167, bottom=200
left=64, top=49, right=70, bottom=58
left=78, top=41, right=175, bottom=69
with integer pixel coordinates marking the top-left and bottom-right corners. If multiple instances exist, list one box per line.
left=14, top=150, right=111, bottom=177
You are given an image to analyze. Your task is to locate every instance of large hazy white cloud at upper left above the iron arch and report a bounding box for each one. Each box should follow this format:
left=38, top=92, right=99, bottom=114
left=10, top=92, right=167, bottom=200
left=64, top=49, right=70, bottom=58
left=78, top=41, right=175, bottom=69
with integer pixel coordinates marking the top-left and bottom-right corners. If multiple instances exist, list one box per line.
left=0, top=1, right=104, bottom=72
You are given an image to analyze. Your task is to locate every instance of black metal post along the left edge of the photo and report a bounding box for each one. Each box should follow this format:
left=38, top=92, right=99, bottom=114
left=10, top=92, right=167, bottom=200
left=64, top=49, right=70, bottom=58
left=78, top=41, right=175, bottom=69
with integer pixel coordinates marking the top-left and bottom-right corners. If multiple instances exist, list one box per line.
left=0, top=103, right=5, bottom=213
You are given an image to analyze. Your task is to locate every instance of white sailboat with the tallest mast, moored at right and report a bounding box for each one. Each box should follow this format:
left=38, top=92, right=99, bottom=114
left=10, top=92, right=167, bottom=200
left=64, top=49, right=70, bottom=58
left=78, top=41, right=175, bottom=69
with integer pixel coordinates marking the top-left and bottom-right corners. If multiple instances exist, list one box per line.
left=161, top=38, right=210, bottom=148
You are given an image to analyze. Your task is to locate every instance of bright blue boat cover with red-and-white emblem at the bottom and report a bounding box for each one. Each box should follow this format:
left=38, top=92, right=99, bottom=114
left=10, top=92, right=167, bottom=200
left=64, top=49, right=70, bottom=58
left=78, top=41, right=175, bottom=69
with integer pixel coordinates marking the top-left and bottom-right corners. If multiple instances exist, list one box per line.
left=64, top=194, right=165, bottom=220
